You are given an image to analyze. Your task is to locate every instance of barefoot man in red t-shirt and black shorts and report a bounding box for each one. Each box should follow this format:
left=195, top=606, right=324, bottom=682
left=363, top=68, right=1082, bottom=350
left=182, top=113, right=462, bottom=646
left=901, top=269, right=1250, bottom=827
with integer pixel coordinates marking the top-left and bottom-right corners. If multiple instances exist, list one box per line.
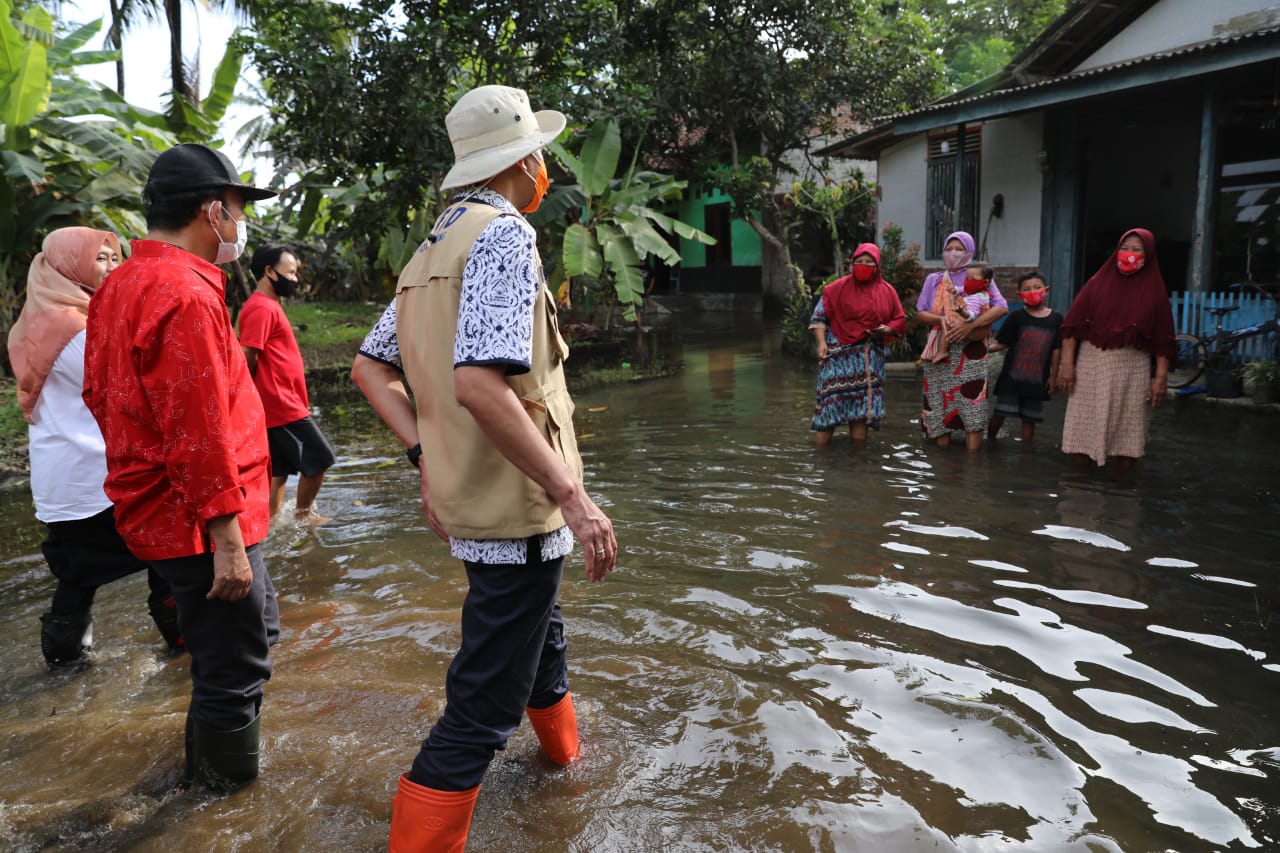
left=239, top=246, right=334, bottom=524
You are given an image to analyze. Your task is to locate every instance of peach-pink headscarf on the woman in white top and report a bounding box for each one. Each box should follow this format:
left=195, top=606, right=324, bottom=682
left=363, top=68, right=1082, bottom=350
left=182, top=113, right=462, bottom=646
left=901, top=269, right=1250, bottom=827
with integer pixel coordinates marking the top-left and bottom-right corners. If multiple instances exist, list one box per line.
left=9, top=228, right=120, bottom=423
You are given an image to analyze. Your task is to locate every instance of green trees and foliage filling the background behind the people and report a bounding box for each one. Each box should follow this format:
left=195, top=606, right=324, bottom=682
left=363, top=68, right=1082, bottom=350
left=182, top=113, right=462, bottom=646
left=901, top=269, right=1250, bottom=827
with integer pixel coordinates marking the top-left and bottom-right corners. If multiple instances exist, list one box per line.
left=0, top=0, right=1066, bottom=361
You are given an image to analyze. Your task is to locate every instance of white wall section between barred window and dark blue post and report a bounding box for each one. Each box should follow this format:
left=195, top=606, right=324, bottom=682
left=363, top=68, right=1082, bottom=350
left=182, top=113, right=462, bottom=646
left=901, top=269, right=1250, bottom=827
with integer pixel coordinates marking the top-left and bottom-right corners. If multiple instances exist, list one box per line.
left=978, top=113, right=1044, bottom=266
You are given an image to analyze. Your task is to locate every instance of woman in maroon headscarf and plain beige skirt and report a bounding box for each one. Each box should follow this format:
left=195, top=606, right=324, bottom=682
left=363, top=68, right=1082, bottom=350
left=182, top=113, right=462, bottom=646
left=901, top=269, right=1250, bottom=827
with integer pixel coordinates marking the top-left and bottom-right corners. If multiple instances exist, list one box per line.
left=1059, top=228, right=1176, bottom=469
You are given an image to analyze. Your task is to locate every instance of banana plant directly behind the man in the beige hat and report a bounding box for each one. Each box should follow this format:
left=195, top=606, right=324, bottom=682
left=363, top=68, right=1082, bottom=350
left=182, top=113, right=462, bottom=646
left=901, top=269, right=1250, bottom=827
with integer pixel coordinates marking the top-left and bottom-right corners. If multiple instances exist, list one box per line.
left=530, top=119, right=716, bottom=321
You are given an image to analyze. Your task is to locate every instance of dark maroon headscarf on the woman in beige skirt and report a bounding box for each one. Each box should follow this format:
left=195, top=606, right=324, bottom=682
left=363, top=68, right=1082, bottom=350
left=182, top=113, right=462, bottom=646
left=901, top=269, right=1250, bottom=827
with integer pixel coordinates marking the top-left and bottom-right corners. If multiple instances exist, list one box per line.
left=1062, top=228, right=1178, bottom=359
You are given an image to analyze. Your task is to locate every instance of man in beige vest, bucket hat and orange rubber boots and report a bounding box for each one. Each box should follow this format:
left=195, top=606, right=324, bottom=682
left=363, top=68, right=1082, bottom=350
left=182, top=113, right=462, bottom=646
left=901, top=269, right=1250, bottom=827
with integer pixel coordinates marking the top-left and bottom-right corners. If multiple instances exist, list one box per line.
left=390, top=86, right=617, bottom=852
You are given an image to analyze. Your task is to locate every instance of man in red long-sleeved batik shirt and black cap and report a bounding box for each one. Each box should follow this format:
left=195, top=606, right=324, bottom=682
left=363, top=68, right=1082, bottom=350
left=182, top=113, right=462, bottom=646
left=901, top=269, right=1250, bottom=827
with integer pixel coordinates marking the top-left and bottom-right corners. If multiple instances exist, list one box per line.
left=84, top=145, right=279, bottom=790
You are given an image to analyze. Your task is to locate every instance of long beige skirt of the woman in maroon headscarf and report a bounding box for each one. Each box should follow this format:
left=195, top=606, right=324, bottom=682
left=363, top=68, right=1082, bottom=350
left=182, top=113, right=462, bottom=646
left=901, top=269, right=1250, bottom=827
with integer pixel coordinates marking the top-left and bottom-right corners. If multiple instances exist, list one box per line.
left=1062, top=341, right=1151, bottom=465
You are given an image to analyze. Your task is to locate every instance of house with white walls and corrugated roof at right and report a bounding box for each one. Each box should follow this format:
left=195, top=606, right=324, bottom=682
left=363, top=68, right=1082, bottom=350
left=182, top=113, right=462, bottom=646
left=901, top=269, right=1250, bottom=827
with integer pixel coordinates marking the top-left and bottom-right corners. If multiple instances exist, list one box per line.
left=823, top=0, right=1280, bottom=309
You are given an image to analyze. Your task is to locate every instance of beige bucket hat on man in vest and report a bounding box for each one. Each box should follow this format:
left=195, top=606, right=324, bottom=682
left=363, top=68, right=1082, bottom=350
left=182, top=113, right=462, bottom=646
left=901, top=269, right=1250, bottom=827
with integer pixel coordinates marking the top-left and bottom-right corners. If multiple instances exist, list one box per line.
left=440, top=86, right=564, bottom=190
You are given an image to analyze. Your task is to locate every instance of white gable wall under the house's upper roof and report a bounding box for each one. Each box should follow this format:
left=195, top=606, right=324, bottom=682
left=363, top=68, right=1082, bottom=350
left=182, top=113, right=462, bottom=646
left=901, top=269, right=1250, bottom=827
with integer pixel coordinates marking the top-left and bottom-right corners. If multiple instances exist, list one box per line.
left=1075, top=0, right=1280, bottom=70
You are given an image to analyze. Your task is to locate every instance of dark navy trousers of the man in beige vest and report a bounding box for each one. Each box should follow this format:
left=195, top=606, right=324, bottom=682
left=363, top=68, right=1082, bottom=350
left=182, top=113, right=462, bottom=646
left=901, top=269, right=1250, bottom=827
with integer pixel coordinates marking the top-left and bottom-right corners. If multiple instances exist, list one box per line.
left=408, top=545, right=568, bottom=790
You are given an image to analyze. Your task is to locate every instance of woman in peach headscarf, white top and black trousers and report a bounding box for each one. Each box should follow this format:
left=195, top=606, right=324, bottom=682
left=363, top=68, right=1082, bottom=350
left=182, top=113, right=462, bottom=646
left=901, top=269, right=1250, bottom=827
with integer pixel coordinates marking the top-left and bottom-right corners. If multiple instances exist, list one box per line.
left=9, top=228, right=182, bottom=671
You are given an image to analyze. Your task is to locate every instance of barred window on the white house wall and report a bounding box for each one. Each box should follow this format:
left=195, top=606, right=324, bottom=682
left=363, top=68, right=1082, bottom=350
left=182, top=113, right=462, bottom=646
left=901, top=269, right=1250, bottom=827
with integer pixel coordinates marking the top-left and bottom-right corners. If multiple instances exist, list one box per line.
left=924, top=126, right=982, bottom=257
